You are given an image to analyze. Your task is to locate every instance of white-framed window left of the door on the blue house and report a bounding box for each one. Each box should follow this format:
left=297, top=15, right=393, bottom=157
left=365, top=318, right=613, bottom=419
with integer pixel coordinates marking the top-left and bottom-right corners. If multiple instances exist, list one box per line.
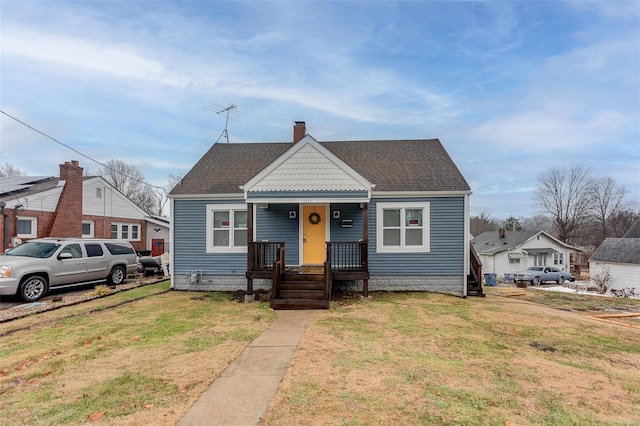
left=206, top=204, right=247, bottom=253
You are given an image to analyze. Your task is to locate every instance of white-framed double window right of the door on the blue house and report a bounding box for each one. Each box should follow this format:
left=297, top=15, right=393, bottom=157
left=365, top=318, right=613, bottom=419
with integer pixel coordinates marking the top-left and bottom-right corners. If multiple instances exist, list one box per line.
left=376, top=202, right=431, bottom=253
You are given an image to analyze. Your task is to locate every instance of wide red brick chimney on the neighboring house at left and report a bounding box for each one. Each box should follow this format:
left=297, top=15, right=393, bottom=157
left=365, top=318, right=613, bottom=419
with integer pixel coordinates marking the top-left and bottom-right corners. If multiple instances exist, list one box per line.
left=48, top=160, right=82, bottom=238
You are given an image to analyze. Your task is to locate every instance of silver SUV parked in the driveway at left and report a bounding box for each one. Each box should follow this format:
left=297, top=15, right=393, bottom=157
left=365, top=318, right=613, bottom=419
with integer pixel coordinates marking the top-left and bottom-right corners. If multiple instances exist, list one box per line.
left=0, top=238, right=138, bottom=302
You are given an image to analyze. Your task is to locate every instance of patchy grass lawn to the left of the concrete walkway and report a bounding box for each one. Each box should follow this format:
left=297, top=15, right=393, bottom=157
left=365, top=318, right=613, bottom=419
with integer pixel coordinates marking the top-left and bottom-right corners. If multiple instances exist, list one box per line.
left=0, top=283, right=275, bottom=425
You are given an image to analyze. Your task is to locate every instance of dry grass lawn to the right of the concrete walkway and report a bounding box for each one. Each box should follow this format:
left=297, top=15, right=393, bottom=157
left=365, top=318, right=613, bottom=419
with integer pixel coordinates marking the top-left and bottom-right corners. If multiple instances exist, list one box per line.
left=264, top=289, right=640, bottom=426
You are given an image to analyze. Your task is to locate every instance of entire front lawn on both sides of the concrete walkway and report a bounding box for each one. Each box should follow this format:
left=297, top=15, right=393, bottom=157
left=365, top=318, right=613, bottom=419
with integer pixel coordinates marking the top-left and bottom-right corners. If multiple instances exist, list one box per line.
left=0, top=282, right=640, bottom=426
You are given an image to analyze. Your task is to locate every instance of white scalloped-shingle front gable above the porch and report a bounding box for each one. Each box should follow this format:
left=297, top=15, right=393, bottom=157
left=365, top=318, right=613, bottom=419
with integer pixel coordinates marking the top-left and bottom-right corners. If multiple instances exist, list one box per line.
left=242, top=135, right=374, bottom=202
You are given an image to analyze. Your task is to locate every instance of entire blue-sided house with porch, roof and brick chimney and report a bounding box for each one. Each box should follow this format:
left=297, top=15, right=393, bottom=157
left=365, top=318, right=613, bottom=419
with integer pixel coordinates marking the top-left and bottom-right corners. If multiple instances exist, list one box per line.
left=170, top=122, right=482, bottom=309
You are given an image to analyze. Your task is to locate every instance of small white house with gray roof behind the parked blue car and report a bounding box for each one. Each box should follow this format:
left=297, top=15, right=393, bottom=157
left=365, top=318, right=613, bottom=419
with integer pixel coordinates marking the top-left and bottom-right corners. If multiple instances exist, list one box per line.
left=471, top=228, right=583, bottom=281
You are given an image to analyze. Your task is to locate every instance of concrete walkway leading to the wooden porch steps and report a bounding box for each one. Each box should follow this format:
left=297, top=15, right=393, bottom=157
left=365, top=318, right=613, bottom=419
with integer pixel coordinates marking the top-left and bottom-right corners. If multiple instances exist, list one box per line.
left=178, top=310, right=322, bottom=426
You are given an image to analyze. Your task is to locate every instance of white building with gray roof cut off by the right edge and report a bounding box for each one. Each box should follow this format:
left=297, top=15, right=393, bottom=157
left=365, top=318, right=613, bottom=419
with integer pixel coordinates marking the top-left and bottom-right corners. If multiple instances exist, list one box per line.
left=589, top=221, right=640, bottom=293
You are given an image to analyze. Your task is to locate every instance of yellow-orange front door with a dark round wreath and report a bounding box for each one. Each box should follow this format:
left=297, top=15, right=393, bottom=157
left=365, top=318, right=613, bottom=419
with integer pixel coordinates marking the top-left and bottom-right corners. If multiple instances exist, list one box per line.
left=301, top=205, right=327, bottom=265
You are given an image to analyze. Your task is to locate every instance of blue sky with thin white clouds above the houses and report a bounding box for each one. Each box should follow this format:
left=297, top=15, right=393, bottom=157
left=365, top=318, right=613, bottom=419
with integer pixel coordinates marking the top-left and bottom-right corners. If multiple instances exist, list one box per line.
left=0, top=0, right=640, bottom=218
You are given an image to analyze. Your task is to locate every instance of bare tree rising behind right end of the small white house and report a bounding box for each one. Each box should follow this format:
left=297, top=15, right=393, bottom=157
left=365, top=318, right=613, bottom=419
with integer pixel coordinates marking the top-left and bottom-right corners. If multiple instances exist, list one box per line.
left=535, top=164, right=593, bottom=242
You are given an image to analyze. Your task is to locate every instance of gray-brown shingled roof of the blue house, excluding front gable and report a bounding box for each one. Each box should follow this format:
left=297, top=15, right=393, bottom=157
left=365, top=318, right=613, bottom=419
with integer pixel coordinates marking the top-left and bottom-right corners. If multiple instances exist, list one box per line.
left=170, top=139, right=470, bottom=195
